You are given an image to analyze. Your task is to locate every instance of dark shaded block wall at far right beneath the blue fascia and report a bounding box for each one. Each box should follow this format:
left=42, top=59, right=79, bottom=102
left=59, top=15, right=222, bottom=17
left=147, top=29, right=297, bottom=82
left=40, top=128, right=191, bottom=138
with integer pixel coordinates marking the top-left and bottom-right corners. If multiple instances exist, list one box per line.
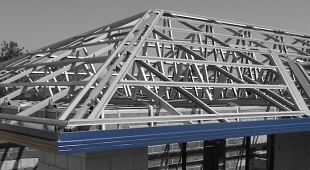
left=274, top=131, right=310, bottom=170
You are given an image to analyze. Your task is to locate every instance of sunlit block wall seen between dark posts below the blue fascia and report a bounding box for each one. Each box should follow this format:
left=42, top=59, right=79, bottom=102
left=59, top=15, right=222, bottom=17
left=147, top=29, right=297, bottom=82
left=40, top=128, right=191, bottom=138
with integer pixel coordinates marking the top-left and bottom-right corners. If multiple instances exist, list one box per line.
left=148, top=136, right=267, bottom=170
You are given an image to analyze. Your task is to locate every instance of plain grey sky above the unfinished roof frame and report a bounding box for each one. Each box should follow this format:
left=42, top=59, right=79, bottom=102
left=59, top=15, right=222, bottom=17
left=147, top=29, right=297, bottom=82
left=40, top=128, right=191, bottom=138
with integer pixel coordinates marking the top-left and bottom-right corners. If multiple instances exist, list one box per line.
left=0, top=0, right=310, bottom=51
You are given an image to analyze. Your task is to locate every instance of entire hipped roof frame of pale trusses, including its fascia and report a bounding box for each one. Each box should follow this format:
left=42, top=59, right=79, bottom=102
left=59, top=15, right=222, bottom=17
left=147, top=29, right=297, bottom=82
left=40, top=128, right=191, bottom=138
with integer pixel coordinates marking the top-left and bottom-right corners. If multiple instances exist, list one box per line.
left=0, top=10, right=310, bottom=154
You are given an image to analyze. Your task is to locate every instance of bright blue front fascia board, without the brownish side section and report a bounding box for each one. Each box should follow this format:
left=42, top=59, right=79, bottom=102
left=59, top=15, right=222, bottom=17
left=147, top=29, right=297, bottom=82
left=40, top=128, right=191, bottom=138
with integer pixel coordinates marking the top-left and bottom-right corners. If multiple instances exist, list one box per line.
left=58, top=118, right=310, bottom=154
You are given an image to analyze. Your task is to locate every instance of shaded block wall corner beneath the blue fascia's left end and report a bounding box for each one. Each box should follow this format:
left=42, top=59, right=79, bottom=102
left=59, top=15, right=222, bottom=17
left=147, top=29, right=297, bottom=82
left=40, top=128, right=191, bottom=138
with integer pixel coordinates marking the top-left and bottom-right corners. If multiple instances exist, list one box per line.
left=38, top=147, right=148, bottom=170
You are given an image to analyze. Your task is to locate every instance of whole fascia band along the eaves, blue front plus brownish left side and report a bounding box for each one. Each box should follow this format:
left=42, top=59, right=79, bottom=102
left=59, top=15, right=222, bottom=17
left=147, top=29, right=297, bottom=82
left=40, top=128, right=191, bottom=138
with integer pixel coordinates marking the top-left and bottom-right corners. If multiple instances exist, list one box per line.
left=0, top=118, right=310, bottom=154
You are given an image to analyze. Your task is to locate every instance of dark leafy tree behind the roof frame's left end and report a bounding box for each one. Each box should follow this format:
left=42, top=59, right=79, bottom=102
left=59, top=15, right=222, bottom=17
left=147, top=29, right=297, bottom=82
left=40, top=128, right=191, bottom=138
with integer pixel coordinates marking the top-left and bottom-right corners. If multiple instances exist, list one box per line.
left=0, top=41, right=27, bottom=98
